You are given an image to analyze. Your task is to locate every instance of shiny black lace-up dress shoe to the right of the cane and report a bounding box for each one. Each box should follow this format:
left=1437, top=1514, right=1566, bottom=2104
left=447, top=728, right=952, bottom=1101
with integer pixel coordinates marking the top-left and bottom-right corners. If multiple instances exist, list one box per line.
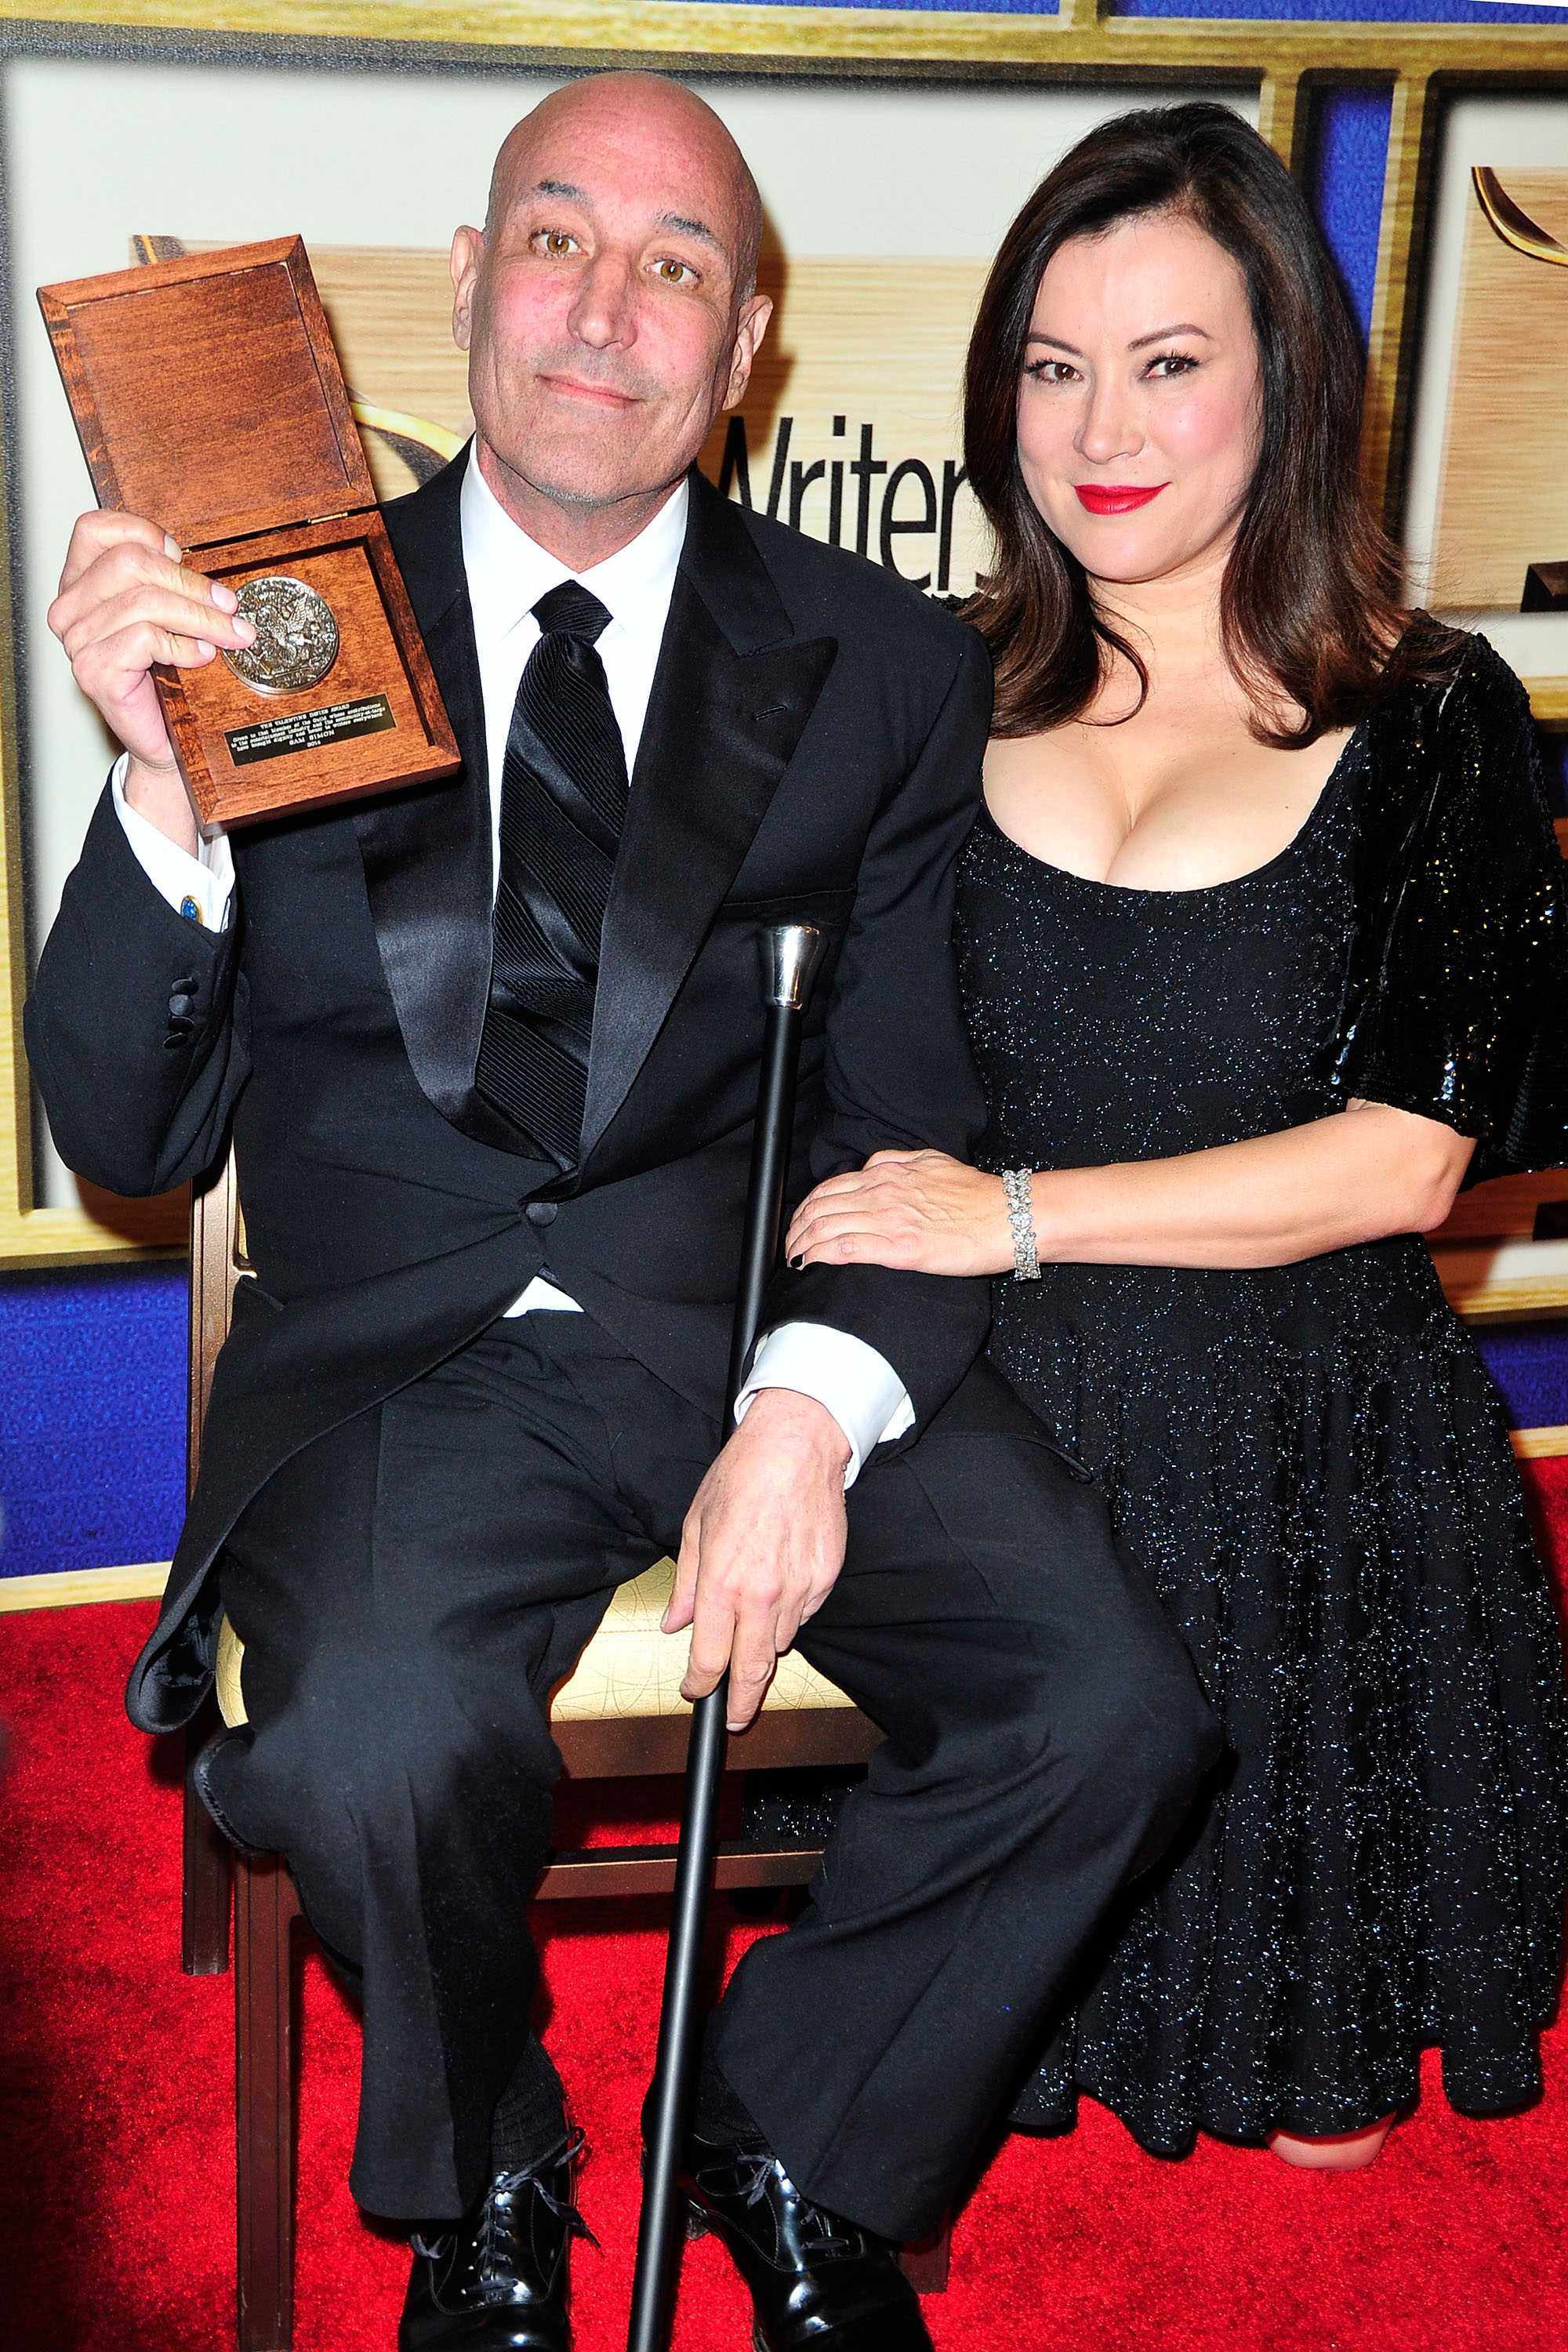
left=682, top=2140, right=931, bottom=2352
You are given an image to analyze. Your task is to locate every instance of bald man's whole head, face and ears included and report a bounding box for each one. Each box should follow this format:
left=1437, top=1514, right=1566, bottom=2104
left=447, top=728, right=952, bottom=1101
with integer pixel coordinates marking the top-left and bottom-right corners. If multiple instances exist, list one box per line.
left=452, top=73, right=774, bottom=569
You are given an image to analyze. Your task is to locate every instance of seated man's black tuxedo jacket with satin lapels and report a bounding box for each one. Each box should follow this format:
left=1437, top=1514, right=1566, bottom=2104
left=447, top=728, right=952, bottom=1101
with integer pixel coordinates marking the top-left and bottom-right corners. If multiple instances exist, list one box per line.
left=26, top=459, right=989, bottom=1731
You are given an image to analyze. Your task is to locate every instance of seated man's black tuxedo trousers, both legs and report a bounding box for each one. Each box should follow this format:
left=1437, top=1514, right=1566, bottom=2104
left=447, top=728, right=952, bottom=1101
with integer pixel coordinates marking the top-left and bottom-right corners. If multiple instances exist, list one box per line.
left=207, top=1312, right=1218, bottom=2239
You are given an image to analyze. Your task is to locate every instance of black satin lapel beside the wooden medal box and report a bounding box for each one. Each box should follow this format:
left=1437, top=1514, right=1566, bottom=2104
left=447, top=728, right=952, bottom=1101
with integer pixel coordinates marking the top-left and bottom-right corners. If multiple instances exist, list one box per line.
left=355, top=569, right=494, bottom=1127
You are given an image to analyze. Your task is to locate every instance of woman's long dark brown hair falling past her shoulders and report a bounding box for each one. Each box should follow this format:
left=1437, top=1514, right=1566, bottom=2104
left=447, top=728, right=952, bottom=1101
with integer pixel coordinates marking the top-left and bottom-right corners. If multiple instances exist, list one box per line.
left=964, top=101, right=1462, bottom=748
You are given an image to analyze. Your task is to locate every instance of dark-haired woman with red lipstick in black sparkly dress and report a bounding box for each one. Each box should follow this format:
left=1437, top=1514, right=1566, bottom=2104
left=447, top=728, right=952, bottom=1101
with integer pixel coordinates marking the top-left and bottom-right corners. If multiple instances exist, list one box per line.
left=787, top=103, right=1568, bottom=2166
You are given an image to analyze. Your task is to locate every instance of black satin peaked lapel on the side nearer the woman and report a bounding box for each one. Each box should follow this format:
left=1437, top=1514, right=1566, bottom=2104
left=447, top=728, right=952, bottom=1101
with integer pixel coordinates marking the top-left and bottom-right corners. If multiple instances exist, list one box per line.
left=583, top=569, right=839, bottom=1162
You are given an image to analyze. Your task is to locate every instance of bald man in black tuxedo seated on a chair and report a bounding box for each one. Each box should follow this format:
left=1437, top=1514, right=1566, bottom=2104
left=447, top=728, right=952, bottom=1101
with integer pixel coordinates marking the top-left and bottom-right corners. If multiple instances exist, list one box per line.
left=28, top=75, right=1215, bottom=2352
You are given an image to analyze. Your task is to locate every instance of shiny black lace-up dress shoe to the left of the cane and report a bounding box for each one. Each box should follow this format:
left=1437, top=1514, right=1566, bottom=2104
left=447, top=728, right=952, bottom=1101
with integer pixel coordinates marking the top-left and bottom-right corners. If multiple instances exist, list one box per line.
left=397, top=2133, right=593, bottom=2352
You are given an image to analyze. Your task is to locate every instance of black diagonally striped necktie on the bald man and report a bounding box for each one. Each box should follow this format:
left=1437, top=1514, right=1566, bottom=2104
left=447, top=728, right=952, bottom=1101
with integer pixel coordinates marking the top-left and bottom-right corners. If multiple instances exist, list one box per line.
left=475, top=581, right=626, bottom=1169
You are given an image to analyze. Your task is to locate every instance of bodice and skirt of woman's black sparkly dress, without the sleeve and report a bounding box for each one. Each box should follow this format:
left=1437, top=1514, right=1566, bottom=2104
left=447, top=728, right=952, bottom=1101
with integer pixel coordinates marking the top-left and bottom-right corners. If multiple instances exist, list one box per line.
left=959, top=677, right=1568, bottom=2154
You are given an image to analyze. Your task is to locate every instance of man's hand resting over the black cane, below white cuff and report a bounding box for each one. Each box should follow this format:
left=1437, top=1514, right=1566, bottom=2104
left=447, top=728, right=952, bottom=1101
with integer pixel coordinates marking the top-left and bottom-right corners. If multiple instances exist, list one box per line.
left=663, top=1388, right=848, bottom=1731
